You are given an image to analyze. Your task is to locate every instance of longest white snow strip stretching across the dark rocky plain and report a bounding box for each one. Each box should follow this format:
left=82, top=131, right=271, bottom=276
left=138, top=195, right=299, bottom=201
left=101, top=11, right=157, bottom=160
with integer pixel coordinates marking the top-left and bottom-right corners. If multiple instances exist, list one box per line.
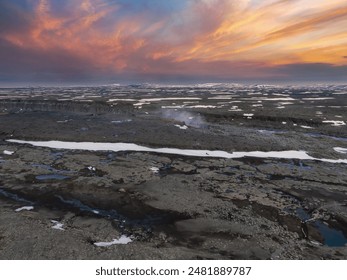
left=7, top=139, right=347, bottom=164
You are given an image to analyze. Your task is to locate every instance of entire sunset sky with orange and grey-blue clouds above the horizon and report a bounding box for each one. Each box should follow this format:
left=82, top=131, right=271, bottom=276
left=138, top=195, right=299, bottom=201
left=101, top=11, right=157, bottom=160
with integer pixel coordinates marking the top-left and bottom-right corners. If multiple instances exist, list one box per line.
left=0, top=0, right=347, bottom=86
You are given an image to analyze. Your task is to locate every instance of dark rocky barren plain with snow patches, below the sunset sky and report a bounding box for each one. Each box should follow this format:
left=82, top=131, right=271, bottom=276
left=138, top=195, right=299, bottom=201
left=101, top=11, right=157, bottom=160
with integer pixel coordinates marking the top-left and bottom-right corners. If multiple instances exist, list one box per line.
left=0, top=85, right=347, bottom=259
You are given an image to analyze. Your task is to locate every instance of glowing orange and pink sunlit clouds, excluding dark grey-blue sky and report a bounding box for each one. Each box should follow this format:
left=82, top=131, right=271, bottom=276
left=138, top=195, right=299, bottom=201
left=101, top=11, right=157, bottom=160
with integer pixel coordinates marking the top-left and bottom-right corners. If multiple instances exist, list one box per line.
left=0, top=0, right=347, bottom=82
